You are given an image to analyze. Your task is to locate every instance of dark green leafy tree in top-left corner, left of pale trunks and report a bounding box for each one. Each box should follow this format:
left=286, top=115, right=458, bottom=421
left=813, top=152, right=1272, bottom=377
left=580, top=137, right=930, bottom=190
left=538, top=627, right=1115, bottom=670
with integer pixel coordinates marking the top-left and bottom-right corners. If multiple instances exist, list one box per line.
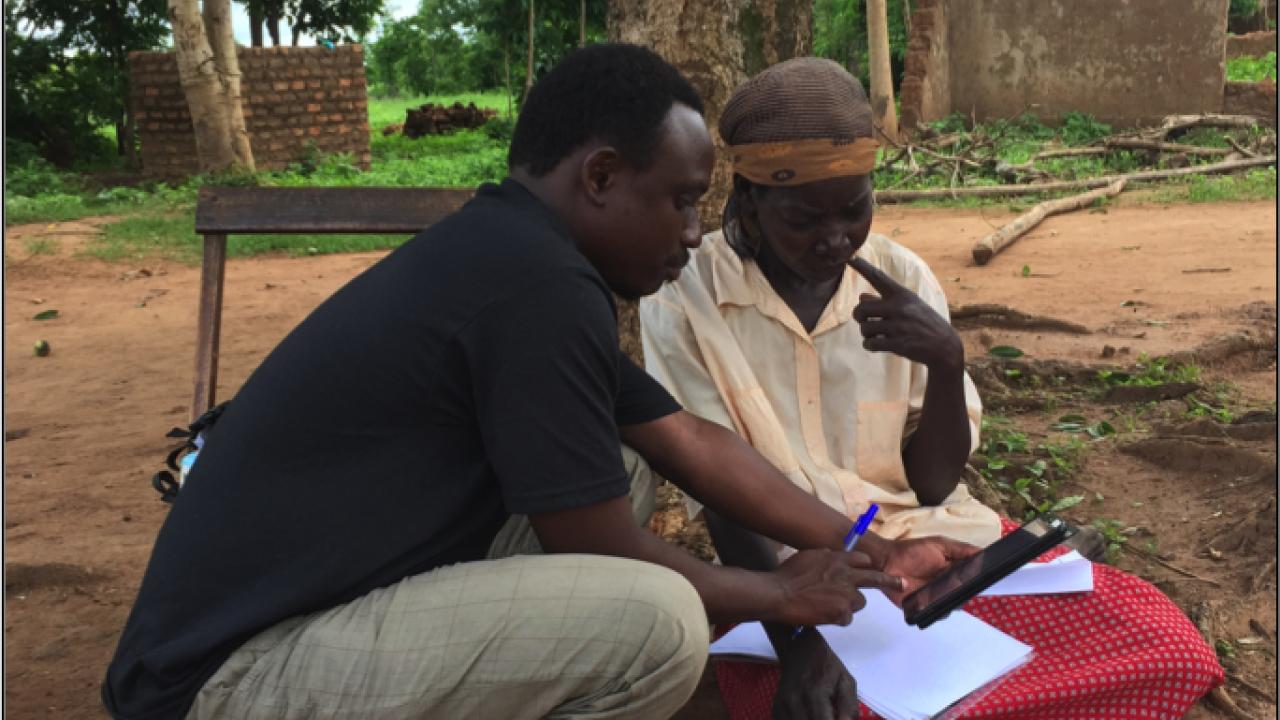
left=4, top=0, right=169, bottom=167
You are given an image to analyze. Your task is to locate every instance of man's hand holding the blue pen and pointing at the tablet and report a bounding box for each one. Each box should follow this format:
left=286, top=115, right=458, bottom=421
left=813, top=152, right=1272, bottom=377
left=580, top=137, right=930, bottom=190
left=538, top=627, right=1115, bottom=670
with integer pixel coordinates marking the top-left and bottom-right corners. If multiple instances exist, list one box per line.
left=769, top=550, right=904, bottom=625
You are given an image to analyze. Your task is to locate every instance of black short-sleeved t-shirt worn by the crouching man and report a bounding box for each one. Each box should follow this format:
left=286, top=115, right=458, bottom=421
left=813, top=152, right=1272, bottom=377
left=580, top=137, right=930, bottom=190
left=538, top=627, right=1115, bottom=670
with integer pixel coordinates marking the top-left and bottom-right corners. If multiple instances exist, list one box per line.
left=102, top=179, right=678, bottom=719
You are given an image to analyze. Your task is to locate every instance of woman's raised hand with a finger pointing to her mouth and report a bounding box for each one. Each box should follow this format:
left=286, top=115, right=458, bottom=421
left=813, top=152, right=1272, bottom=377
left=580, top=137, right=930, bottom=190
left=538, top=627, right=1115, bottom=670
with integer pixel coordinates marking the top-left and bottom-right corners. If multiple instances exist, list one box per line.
left=849, top=256, right=964, bottom=370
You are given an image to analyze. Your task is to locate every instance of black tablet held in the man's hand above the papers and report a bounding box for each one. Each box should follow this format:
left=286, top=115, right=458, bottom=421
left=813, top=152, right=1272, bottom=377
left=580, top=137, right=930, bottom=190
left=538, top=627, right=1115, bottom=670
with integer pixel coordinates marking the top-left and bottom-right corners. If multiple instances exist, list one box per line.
left=902, top=512, right=1075, bottom=629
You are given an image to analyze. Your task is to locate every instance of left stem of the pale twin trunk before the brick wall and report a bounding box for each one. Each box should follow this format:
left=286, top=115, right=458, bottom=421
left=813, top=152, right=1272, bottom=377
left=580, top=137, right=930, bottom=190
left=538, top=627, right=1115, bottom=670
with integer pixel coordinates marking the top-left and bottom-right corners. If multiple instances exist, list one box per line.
left=169, top=0, right=237, bottom=173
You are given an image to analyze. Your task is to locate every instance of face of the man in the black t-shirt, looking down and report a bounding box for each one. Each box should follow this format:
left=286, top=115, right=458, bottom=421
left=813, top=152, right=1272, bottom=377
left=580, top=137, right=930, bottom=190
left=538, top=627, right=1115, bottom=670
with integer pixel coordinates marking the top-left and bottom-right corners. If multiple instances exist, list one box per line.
left=584, top=104, right=716, bottom=300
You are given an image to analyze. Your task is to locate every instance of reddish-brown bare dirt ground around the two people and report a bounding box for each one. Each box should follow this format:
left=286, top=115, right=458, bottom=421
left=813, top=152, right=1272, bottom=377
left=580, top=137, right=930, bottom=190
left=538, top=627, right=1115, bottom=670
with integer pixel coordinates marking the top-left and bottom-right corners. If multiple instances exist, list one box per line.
left=4, top=197, right=1276, bottom=719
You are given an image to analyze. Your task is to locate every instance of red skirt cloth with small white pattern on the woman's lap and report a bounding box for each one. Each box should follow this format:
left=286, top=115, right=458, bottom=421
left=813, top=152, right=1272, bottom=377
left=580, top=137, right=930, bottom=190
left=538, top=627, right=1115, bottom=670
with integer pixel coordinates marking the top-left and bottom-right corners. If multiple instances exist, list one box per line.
left=716, top=518, right=1222, bottom=720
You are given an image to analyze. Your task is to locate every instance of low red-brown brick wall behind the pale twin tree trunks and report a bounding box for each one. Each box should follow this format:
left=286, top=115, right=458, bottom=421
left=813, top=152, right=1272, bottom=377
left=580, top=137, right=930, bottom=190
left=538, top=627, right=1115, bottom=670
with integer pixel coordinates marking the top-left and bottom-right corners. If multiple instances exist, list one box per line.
left=129, top=45, right=369, bottom=177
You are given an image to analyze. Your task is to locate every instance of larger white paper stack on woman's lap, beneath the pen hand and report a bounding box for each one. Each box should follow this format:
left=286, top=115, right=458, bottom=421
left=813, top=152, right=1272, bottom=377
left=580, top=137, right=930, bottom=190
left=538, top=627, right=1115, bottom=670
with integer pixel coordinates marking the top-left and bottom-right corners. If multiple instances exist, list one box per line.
left=712, top=589, right=1032, bottom=720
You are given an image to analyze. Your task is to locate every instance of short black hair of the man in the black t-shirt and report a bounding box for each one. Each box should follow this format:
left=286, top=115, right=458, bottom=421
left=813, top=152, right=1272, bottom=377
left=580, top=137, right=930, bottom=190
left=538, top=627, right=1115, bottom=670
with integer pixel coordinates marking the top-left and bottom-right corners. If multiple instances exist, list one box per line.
left=507, top=44, right=703, bottom=177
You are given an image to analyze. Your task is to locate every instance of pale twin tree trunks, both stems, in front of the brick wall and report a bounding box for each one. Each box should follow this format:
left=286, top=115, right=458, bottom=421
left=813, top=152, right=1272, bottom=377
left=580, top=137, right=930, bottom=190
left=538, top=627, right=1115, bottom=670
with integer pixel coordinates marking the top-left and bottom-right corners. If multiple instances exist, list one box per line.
left=169, top=0, right=253, bottom=173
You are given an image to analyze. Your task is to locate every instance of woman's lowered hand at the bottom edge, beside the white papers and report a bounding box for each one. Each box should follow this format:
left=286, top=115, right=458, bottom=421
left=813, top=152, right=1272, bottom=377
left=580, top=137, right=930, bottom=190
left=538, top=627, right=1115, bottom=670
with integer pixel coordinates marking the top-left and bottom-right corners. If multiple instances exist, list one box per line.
left=773, top=629, right=858, bottom=720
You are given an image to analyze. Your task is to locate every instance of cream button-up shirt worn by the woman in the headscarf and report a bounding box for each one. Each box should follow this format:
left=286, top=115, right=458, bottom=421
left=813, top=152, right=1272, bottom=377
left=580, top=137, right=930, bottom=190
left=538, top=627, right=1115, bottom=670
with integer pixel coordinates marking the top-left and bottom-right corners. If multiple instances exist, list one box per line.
left=640, top=232, right=1000, bottom=555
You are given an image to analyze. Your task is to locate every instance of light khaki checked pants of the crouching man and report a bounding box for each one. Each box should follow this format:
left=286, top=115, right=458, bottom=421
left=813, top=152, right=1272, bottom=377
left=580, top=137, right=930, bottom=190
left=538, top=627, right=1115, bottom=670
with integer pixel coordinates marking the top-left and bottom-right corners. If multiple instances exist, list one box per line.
left=188, top=448, right=708, bottom=720
